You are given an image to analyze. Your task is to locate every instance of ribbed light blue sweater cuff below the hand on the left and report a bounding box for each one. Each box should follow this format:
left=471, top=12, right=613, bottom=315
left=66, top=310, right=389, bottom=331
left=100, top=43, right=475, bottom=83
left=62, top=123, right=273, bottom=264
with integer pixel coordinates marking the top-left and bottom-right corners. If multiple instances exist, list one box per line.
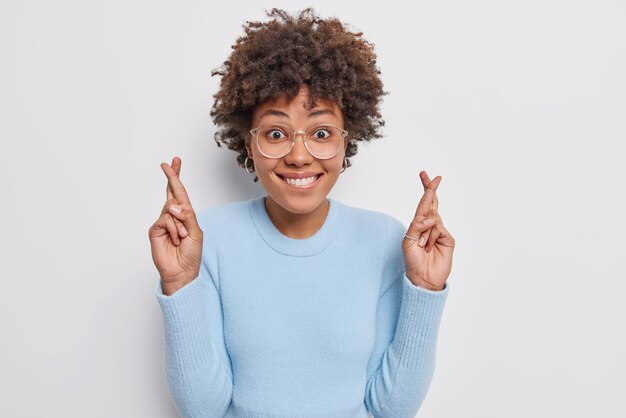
left=156, top=277, right=216, bottom=375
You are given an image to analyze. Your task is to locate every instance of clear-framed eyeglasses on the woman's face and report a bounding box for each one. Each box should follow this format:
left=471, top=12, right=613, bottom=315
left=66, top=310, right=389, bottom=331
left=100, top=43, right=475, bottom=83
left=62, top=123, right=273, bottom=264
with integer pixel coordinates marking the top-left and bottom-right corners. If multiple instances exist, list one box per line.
left=250, top=123, right=348, bottom=160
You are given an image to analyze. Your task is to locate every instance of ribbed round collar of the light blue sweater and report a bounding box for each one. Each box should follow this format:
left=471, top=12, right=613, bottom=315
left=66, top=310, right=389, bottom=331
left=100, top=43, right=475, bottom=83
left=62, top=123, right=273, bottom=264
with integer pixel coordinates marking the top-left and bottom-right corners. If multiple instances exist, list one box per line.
left=249, top=196, right=344, bottom=257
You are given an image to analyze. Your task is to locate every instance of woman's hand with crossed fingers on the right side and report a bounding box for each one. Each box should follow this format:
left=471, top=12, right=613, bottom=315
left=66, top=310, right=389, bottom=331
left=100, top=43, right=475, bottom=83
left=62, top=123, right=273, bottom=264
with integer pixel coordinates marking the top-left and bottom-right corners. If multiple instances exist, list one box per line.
left=402, top=171, right=455, bottom=290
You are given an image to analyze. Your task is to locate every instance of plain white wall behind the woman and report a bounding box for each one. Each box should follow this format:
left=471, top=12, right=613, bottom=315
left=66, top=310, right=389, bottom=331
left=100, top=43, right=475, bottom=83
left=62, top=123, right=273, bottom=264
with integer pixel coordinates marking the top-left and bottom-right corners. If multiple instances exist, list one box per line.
left=0, top=0, right=626, bottom=418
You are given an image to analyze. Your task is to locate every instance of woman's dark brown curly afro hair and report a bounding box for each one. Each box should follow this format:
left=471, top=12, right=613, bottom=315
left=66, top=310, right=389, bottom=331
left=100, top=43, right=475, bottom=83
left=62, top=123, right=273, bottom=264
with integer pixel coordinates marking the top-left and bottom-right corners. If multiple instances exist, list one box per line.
left=210, top=7, right=388, bottom=181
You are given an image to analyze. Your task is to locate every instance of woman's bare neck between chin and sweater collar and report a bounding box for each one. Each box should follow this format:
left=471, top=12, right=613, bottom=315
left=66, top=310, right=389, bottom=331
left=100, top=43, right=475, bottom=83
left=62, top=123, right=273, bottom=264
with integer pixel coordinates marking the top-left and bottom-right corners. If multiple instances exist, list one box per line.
left=265, top=196, right=330, bottom=239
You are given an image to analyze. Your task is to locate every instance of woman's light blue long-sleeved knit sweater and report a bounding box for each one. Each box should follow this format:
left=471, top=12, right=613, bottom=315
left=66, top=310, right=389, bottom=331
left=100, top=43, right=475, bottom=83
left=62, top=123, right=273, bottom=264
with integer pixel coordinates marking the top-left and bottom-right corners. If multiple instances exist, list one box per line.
left=156, top=197, right=449, bottom=418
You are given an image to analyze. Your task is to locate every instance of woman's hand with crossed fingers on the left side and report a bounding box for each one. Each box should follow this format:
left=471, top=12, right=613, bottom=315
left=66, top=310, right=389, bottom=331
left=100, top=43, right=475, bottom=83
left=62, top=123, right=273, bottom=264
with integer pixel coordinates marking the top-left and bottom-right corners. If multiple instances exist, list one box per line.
left=148, top=157, right=203, bottom=295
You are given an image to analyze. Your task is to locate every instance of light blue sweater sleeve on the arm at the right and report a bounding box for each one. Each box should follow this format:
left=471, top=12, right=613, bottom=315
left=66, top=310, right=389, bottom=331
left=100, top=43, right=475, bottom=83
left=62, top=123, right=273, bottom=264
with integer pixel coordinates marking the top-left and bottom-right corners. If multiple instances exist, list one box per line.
left=365, top=219, right=449, bottom=418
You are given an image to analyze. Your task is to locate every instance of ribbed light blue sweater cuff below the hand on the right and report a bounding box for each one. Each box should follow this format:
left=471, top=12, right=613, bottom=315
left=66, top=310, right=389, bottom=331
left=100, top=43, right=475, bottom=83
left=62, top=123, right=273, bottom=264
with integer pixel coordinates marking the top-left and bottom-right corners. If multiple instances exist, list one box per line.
left=391, top=274, right=449, bottom=369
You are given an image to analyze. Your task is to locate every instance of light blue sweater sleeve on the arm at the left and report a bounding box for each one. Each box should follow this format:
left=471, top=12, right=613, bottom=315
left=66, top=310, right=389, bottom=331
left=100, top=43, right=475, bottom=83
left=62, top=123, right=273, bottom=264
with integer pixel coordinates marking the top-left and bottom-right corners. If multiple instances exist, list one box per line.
left=156, top=236, right=233, bottom=418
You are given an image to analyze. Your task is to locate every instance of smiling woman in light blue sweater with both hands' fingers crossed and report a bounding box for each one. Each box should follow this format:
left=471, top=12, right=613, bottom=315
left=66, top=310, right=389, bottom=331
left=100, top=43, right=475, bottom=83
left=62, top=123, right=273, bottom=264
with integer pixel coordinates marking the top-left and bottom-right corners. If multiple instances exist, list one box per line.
left=149, top=9, right=455, bottom=418
